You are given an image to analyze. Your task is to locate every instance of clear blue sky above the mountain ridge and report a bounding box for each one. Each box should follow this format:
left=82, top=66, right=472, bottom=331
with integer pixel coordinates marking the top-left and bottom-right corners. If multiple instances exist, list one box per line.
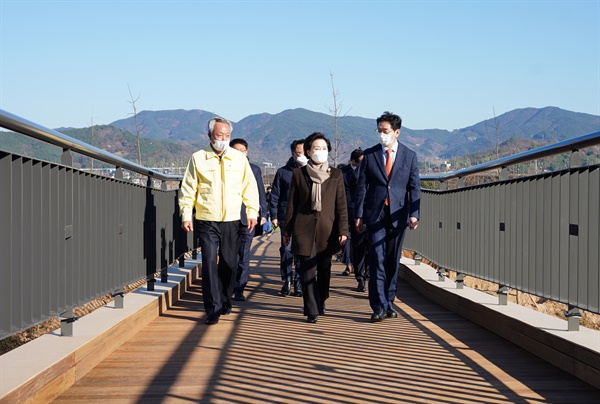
left=0, top=0, right=600, bottom=130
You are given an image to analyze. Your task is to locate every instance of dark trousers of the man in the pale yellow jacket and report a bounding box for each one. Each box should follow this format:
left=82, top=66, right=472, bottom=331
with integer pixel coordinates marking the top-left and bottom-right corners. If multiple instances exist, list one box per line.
left=196, top=220, right=241, bottom=316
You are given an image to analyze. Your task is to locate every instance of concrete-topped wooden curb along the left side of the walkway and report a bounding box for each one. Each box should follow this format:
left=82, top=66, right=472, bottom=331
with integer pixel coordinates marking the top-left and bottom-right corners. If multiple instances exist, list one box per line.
left=0, top=260, right=201, bottom=403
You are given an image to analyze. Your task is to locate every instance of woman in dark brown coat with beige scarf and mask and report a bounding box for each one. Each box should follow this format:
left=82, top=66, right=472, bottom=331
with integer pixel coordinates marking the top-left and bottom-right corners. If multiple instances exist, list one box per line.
left=283, top=132, right=348, bottom=323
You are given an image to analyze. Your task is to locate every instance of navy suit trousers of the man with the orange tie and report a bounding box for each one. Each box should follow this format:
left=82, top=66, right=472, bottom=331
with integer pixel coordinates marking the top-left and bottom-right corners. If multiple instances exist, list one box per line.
left=367, top=207, right=407, bottom=312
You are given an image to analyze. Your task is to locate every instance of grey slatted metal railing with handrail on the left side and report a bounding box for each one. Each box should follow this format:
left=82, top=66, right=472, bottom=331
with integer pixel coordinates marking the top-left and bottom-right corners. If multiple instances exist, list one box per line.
left=0, top=110, right=193, bottom=338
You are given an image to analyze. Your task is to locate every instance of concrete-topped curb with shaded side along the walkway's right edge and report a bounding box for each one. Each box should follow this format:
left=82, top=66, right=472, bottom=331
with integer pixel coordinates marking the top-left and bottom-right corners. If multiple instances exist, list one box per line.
left=399, top=258, right=600, bottom=388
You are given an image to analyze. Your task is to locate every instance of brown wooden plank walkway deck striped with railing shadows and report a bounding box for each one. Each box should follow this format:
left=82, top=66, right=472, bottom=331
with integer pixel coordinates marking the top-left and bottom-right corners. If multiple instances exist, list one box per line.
left=55, top=234, right=600, bottom=404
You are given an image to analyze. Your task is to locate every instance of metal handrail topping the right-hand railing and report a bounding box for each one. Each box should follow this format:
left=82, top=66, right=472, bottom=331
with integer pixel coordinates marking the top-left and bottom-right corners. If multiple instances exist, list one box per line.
left=421, top=131, right=600, bottom=182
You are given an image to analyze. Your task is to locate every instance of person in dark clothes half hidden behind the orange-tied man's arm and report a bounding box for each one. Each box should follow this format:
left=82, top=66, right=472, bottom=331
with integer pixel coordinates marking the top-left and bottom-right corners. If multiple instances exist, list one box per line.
left=341, top=148, right=368, bottom=292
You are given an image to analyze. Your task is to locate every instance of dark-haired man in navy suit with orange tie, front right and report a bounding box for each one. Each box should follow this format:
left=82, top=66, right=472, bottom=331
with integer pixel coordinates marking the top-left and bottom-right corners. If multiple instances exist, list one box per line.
left=355, top=112, right=421, bottom=322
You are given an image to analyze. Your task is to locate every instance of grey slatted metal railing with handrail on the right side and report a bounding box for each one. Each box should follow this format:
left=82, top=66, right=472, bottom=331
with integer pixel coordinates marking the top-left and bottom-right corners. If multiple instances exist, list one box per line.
left=404, top=132, right=600, bottom=329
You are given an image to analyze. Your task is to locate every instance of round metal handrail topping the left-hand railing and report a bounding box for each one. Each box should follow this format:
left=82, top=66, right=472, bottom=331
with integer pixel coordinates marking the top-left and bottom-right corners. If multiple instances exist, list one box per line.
left=0, top=109, right=183, bottom=181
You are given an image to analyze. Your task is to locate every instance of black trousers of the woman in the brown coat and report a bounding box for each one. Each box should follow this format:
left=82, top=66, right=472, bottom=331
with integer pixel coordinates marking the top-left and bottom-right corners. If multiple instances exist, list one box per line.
left=298, top=254, right=331, bottom=316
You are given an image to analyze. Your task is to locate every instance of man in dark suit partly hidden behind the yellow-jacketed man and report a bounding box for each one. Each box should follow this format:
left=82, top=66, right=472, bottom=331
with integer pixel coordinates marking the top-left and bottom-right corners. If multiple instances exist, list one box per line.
left=229, top=138, right=267, bottom=302
